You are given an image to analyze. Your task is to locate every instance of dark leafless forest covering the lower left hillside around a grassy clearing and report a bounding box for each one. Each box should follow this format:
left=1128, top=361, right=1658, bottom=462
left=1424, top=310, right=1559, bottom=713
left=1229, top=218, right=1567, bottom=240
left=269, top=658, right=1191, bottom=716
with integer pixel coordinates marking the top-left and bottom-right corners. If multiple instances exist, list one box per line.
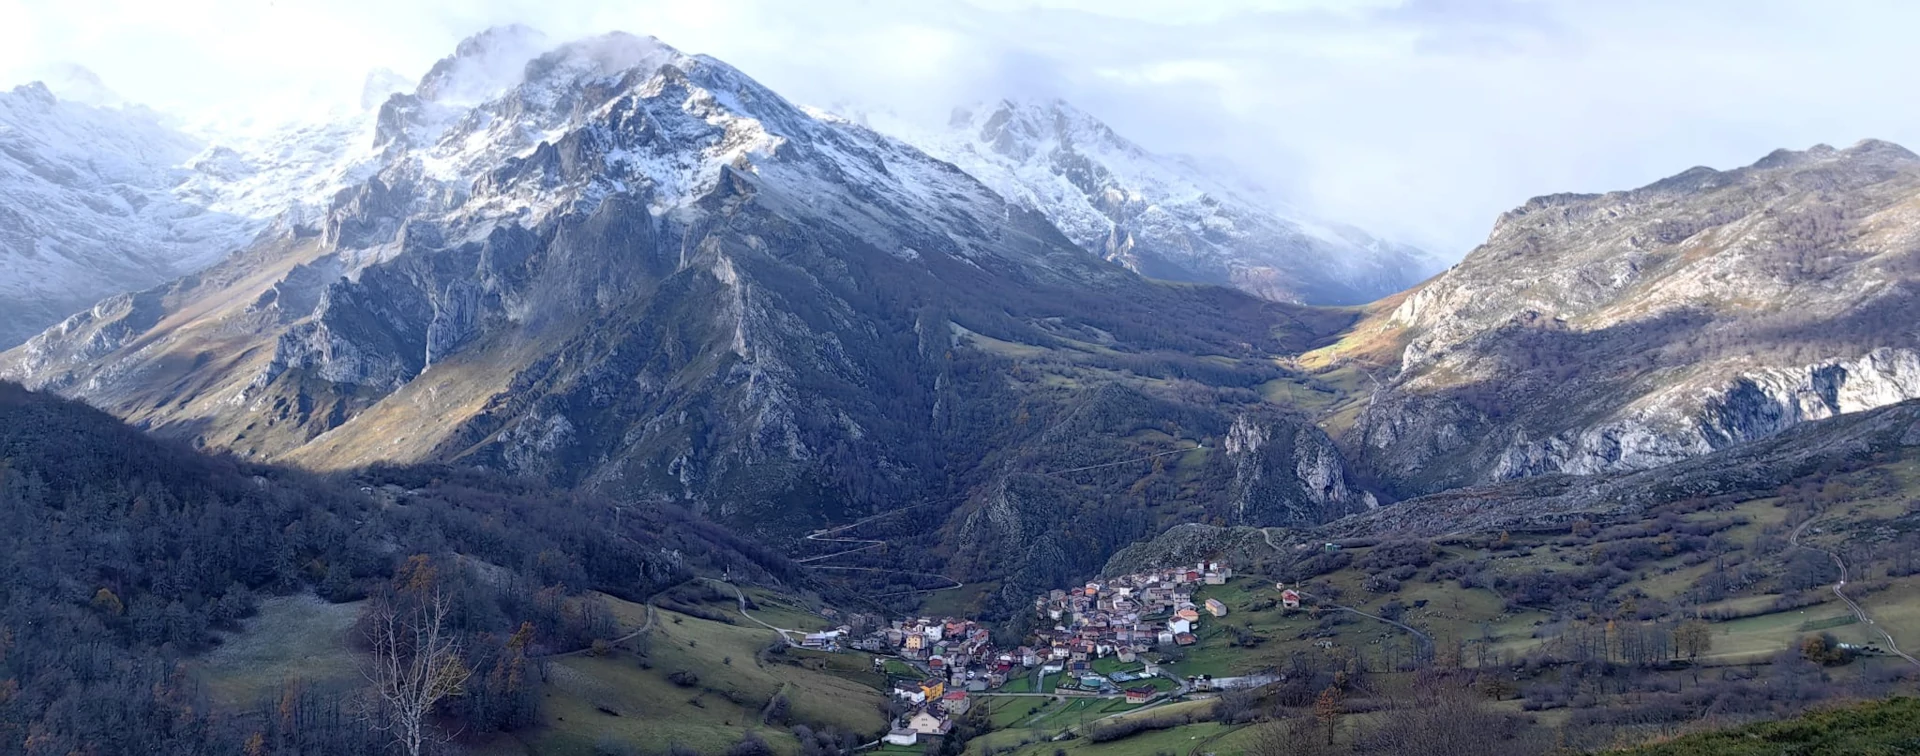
left=0, top=384, right=799, bottom=754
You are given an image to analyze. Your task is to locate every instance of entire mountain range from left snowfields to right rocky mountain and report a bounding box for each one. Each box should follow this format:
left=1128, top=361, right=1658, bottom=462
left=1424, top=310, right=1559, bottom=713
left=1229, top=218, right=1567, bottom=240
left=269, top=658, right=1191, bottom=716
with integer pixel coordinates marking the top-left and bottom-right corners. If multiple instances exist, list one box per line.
left=0, top=27, right=1920, bottom=610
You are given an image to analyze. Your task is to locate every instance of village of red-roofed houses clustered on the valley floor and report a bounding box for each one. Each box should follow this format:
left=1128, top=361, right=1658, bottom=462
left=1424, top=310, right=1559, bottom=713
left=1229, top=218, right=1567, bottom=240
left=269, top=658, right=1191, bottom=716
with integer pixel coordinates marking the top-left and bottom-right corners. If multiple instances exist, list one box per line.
left=779, top=562, right=1300, bottom=746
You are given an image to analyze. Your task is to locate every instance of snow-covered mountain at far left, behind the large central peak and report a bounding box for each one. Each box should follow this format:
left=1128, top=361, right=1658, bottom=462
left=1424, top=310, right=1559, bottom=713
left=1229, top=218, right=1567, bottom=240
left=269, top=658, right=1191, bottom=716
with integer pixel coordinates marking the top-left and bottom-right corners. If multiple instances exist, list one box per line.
left=0, top=65, right=411, bottom=347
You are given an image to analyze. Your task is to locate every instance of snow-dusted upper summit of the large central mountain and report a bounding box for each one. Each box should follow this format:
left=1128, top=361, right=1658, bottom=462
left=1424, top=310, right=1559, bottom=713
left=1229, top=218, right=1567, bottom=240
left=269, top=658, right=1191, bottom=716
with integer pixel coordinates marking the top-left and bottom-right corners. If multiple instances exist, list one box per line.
left=307, top=27, right=1098, bottom=278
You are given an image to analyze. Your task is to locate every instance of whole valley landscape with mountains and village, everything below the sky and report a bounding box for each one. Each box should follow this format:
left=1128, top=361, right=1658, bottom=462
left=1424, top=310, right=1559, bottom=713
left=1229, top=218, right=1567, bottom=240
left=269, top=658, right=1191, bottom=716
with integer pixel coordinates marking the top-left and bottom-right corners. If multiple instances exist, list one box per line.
left=0, top=14, right=1920, bottom=756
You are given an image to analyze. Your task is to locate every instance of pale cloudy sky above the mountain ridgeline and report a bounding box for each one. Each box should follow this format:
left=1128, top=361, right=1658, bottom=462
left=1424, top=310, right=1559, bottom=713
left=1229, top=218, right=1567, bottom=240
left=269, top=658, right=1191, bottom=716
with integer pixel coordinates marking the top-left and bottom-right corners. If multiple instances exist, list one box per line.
left=0, top=0, right=1920, bottom=257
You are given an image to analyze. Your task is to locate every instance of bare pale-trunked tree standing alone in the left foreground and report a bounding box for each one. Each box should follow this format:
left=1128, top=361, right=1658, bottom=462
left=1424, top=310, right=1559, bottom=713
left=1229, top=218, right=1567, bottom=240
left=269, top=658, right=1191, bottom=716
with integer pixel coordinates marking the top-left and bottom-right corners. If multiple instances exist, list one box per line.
left=365, top=587, right=470, bottom=756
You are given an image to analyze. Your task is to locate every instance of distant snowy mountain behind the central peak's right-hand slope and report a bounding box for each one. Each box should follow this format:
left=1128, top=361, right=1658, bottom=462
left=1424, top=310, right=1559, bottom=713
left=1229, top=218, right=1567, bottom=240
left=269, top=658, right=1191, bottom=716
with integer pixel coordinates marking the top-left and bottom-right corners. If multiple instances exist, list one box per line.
left=858, top=100, right=1440, bottom=305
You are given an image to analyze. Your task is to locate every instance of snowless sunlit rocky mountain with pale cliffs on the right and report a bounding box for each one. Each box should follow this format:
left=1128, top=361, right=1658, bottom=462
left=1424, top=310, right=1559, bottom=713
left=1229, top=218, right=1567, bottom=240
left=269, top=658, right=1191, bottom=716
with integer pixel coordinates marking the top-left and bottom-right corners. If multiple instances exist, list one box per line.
left=1346, top=142, right=1920, bottom=495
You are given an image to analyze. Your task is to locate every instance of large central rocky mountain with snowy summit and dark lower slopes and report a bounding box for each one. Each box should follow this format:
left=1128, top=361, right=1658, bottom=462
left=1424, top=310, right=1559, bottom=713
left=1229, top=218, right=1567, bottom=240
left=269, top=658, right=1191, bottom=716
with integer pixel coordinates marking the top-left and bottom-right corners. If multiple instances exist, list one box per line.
left=0, top=29, right=1365, bottom=610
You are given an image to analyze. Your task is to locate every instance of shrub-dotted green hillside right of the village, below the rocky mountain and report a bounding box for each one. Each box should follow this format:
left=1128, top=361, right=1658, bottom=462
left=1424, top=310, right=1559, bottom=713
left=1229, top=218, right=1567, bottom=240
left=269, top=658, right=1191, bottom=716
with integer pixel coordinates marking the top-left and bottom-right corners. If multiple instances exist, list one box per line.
left=1008, top=439, right=1920, bottom=754
